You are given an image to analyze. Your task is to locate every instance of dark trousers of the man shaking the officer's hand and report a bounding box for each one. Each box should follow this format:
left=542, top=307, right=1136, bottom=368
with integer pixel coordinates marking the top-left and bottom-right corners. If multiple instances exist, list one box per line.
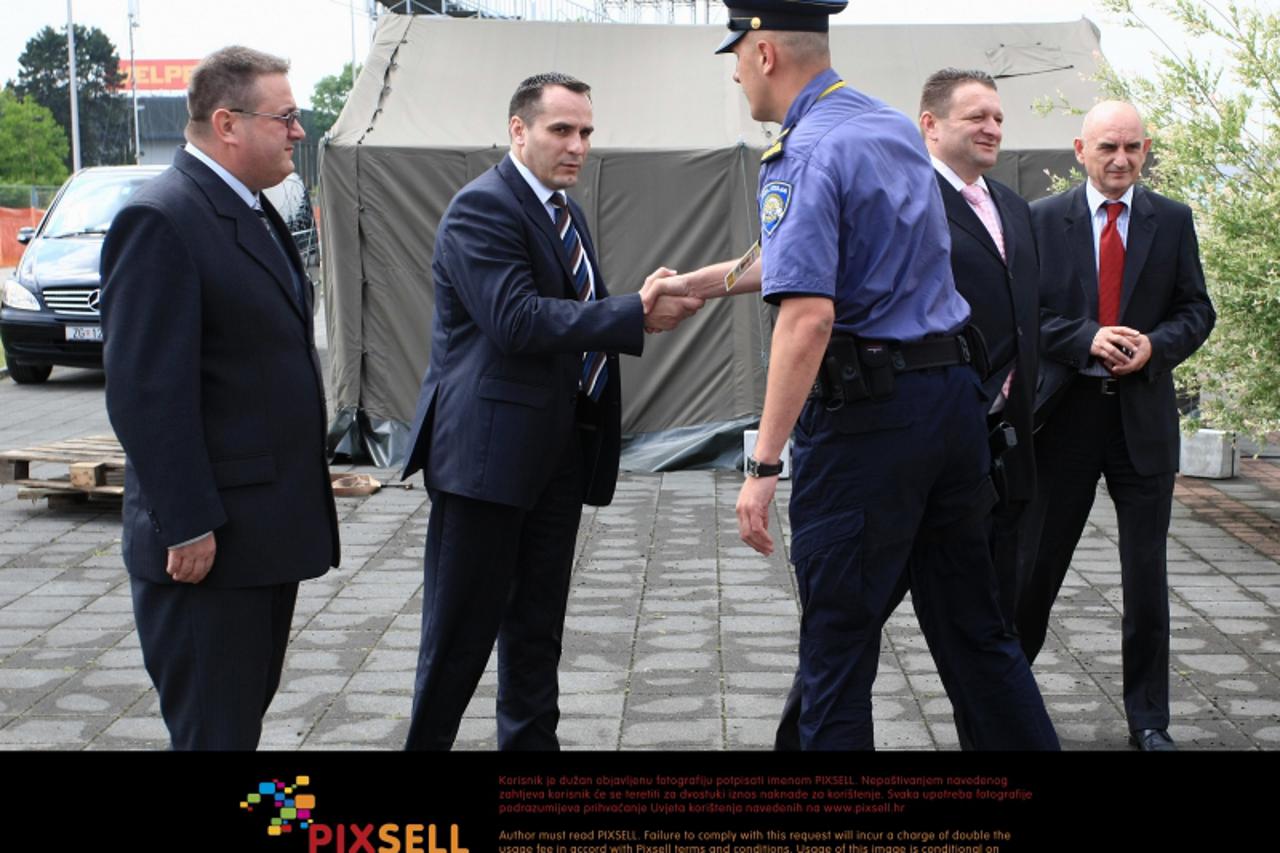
left=404, top=437, right=582, bottom=749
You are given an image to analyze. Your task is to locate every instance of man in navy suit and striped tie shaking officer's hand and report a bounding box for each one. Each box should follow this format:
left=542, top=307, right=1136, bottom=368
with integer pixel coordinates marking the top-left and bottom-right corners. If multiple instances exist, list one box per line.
left=404, top=73, right=701, bottom=749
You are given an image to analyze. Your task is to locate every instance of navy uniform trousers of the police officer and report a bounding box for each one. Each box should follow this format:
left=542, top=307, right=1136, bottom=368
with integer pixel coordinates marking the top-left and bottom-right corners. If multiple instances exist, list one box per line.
left=791, top=366, right=1059, bottom=749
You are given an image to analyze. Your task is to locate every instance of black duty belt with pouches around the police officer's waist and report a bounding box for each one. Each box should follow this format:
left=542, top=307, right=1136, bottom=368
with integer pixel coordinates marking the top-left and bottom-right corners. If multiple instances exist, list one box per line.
left=809, top=327, right=986, bottom=411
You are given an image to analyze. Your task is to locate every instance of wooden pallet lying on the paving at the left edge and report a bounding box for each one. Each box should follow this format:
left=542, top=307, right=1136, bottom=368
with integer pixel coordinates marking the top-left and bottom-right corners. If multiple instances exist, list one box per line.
left=0, top=435, right=124, bottom=501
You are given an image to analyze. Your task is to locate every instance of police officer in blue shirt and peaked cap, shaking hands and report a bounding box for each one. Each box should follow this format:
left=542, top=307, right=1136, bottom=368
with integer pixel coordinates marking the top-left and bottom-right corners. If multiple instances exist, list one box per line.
left=689, top=0, right=1057, bottom=749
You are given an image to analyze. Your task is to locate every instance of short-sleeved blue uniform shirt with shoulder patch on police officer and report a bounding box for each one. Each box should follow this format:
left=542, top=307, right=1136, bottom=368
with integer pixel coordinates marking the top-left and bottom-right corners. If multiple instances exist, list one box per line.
left=759, top=69, right=969, bottom=341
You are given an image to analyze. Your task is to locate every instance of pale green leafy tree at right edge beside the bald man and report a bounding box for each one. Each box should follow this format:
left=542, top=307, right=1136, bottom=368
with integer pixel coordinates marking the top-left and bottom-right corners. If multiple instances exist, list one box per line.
left=1108, top=0, right=1280, bottom=437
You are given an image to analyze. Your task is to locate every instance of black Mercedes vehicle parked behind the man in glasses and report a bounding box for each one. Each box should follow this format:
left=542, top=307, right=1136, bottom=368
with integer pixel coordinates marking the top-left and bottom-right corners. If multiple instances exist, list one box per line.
left=0, top=165, right=164, bottom=383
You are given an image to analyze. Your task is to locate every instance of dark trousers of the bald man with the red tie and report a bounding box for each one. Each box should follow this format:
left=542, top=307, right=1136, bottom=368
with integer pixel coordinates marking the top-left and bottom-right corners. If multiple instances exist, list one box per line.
left=1018, top=377, right=1174, bottom=730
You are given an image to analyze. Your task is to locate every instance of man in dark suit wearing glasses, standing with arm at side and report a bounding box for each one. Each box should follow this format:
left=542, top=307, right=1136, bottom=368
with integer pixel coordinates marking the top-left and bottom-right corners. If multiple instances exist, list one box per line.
left=102, top=47, right=339, bottom=749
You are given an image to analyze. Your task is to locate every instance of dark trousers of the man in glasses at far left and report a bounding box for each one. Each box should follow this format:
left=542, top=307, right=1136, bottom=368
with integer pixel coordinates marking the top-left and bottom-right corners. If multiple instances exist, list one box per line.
left=129, top=576, right=298, bottom=749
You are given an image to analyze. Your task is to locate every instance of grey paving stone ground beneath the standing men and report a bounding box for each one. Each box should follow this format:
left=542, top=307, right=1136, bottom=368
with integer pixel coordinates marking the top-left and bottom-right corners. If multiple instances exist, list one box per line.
left=0, top=307, right=1280, bottom=749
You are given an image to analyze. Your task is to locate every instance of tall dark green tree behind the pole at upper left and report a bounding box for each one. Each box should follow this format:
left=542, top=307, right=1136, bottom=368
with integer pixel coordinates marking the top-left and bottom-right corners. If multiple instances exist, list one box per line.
left=13, top=24, right=132, bottom=167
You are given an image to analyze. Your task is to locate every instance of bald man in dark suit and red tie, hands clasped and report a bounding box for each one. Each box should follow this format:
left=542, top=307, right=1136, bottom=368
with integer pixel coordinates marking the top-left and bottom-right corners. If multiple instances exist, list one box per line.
left=1018, top=101, right=1215, bottom=751
